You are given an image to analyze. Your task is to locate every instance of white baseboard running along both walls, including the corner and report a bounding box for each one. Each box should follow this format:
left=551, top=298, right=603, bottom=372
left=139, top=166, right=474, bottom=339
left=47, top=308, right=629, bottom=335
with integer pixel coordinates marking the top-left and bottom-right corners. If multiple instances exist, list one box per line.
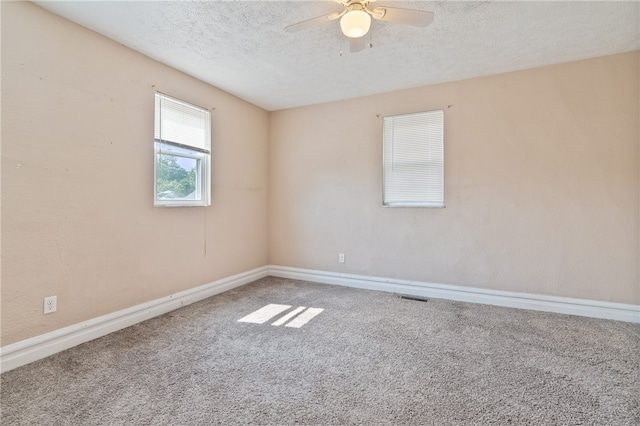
left=0, top=265, right=640, bottom=372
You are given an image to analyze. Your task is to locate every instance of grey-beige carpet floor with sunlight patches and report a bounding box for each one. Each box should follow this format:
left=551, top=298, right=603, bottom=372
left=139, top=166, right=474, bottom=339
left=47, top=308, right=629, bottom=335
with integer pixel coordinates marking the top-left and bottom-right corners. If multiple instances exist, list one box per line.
left=0, top=277, right=640, bottom=426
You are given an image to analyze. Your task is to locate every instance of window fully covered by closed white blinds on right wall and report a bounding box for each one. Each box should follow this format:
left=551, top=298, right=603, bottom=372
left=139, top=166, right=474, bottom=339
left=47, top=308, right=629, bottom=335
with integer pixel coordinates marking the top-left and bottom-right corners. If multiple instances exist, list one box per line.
left=382, top=110, right=444, bottom=207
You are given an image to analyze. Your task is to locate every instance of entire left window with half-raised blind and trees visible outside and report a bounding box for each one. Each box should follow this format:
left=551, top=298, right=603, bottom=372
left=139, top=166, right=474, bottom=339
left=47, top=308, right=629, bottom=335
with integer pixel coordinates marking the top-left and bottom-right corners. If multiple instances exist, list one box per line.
left=154, top=93, right=211, bottom=207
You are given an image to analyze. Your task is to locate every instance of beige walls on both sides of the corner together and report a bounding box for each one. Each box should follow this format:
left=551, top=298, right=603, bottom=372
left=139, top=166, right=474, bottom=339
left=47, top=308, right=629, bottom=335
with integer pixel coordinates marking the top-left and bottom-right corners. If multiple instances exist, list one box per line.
left=1, top=2, right=640, bottom=346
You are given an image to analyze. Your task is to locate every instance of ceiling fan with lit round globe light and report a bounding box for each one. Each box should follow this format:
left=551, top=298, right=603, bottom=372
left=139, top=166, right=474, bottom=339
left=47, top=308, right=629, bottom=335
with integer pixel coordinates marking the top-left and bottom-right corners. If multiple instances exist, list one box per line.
left=285, top=0, right=433, bottom=52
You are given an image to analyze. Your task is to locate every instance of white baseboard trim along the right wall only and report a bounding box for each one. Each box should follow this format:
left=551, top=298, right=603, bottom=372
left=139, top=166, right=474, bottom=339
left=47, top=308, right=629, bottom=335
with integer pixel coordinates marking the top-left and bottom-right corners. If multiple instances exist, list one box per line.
left=269, top=265, right=640, bottom=323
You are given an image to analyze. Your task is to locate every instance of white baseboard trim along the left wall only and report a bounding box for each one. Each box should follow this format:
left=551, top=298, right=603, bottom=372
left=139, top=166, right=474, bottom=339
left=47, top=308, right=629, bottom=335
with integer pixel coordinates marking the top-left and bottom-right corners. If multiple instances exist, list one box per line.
left=0, top=266, right=269, bottom=372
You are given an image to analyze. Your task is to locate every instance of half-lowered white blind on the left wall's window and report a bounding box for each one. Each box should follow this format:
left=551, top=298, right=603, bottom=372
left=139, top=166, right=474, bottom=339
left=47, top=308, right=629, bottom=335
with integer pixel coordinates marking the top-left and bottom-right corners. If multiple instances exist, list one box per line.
left=155, top=93, right=211, bottom=152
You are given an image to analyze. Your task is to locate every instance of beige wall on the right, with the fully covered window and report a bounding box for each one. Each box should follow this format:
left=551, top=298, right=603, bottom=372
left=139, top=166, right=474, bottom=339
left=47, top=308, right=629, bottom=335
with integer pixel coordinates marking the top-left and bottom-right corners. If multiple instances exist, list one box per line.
left=269, top=52, right=640, bottom=304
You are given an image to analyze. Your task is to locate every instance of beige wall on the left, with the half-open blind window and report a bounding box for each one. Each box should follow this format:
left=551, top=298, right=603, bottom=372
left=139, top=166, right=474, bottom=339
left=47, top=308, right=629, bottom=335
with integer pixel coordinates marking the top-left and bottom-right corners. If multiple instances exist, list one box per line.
left=1, top=2, right=269, bottom=346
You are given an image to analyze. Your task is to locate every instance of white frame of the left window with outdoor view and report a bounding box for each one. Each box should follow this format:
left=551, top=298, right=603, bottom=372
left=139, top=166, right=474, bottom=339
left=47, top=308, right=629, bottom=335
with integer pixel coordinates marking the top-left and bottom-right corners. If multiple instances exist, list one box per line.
left=153, top=92, right=211, bottom=207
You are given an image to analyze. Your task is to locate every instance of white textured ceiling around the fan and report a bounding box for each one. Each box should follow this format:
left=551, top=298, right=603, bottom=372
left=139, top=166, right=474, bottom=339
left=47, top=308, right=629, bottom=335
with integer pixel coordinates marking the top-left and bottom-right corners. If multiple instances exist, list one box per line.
left=36, top=0, right=640, bottom=111
